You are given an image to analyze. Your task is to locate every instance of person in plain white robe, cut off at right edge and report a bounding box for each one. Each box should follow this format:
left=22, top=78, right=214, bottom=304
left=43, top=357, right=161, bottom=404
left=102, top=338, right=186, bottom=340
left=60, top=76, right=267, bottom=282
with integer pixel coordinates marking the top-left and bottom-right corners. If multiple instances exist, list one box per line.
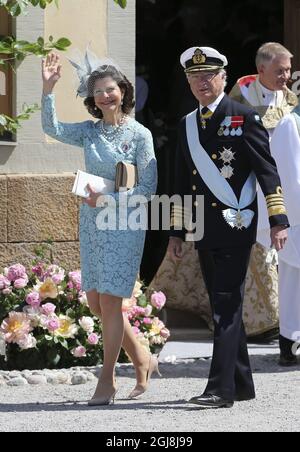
left=258, top=106, right=300, bottom=366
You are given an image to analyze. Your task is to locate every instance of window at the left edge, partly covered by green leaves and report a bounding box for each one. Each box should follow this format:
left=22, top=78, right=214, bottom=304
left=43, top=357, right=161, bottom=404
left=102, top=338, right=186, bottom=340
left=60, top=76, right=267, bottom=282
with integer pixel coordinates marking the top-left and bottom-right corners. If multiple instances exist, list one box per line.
left=0, top=8, right=12, bottom=141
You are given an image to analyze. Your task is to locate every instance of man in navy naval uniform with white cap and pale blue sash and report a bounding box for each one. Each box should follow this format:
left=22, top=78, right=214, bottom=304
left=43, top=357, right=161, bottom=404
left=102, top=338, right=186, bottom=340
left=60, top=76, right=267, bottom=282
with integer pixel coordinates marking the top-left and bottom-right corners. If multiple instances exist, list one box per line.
left=168, top=47, right=289, bottom=408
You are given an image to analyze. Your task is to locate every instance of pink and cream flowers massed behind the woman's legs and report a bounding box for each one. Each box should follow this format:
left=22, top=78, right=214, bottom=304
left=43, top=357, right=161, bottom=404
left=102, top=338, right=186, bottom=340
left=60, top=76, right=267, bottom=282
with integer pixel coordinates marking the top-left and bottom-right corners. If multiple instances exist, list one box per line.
left=0, top=247, right=169, bottom=370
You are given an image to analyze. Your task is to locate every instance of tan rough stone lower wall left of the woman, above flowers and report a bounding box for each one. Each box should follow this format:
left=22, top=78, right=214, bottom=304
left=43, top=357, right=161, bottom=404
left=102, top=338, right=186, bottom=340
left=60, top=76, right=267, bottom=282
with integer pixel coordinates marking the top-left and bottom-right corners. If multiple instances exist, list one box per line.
left=0, top=173, right=80, bottom=270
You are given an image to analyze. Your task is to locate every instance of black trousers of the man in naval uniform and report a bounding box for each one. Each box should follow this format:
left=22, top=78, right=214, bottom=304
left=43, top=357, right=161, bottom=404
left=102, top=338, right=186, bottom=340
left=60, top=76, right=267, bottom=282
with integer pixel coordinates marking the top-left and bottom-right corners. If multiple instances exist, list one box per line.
left=199, top=246, right=255, bottom=401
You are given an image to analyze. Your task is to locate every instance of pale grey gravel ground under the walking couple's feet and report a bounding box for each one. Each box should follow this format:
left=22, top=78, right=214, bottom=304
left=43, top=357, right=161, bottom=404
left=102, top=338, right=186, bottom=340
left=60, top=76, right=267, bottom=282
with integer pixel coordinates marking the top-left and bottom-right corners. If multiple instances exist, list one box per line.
left=0, top=355, right=300, bottom=432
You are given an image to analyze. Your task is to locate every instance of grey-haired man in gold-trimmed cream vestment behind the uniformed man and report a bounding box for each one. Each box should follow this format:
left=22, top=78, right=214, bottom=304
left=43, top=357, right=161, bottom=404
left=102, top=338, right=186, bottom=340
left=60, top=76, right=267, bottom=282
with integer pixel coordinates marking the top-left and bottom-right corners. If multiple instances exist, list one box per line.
left=230, top=42, right=298, bottom=339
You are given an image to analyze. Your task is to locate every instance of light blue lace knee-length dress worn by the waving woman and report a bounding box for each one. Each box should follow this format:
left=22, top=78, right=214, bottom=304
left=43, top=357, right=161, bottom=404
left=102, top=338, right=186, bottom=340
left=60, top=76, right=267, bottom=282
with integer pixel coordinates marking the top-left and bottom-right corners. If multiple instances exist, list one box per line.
left=42, top=94, right=157, bottom=298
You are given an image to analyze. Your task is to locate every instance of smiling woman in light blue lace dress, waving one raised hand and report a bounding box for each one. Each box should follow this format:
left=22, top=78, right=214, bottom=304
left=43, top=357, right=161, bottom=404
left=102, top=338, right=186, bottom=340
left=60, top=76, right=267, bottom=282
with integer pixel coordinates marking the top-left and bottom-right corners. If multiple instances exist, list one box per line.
left=42, top=53, right=158, bottom=405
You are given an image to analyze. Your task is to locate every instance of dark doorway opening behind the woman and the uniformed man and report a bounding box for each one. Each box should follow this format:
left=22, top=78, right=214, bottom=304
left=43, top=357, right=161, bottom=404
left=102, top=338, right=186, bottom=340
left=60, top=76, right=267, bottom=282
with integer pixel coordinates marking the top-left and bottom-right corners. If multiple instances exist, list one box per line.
left=136, top=0, right=284, bottom=283
